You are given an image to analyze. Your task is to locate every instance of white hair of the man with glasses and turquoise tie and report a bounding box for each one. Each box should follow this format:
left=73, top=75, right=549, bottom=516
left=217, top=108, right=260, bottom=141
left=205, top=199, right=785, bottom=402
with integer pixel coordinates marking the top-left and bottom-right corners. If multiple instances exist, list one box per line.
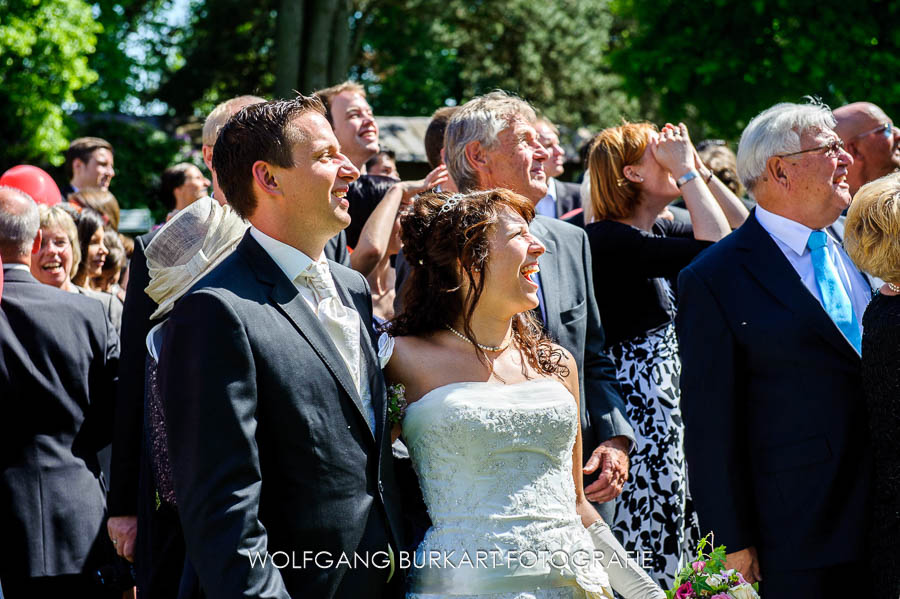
left=737, top=99, right=836, bottom=194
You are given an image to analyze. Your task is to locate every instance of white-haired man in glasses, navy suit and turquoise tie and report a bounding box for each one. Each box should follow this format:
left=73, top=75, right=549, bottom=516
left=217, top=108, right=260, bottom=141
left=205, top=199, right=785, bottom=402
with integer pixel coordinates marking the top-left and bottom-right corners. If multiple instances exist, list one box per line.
left=676, top=104, right=871, bottom=599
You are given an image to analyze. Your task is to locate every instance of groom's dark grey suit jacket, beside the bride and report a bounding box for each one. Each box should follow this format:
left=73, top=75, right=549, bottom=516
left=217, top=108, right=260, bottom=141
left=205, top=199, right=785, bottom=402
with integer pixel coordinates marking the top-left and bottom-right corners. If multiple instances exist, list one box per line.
left=159, top=233, right=400, bottom=599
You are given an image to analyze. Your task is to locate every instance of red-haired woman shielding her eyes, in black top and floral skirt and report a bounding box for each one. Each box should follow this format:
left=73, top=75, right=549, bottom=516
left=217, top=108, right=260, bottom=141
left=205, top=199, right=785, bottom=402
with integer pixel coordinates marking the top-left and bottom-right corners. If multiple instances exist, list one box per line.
left=585, top=123, right=747, bottom=586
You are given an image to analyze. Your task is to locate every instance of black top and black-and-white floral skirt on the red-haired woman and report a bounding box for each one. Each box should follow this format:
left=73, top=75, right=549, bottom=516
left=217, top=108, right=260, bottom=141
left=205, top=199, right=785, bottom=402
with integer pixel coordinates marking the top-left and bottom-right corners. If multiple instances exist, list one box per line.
left=586, top=221, right=710, bottom=588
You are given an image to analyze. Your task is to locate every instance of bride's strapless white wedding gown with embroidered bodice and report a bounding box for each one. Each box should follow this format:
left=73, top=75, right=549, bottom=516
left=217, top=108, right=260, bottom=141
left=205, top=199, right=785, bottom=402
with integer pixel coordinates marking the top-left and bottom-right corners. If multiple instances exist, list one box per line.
left=403, top=379, right=612, bottom=599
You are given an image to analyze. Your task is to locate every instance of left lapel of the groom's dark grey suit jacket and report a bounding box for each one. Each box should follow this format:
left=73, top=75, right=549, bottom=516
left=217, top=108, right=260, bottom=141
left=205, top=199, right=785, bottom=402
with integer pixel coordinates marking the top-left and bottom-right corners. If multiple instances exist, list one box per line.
left=238, top=237, right=371, bottom=438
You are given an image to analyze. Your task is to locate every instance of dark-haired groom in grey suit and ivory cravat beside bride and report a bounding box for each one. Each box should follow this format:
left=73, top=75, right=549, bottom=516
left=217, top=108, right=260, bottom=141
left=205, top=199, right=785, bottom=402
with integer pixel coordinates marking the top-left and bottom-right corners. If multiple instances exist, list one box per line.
left=159, top=96, right=400, bottom=599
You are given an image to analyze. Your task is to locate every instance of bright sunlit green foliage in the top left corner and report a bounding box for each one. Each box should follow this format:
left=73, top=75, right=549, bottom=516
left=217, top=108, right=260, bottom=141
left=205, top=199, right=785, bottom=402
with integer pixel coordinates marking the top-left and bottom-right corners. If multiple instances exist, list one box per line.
left=0, top=0, right=100, bottom=168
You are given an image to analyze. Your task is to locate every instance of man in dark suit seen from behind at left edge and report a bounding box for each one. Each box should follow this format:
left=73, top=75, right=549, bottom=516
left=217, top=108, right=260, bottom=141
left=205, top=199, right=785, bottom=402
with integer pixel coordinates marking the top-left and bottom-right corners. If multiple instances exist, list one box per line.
left=0, top=187, right=119, bottom=599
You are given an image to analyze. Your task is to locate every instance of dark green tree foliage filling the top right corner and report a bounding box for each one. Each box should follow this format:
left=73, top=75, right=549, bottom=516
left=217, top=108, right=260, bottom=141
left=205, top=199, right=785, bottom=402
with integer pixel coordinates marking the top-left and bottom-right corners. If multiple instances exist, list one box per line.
left=612, top=0, right=900, bottom=139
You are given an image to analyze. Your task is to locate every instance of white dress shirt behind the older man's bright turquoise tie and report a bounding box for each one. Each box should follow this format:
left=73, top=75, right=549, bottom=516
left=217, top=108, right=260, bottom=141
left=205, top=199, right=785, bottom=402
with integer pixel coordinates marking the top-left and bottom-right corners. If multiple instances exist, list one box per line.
left=756, top=205, right=872, bottom=342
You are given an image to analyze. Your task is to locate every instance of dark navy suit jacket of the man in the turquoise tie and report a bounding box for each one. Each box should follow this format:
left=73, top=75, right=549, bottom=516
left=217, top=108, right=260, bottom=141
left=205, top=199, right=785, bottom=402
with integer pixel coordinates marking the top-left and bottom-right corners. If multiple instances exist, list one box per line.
left=676, top=213, right=870, bottom=577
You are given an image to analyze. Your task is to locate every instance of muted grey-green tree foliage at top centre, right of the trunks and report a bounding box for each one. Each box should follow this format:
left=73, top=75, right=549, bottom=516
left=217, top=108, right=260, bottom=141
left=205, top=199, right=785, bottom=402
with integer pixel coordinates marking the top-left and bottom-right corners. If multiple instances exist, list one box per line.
left=360, top=0, right=636, bottom=132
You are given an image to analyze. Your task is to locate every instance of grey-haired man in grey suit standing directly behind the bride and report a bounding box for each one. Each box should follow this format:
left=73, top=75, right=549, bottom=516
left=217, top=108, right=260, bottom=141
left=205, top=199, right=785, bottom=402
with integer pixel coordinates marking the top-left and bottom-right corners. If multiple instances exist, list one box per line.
left=397, top=92, right=634, bottom=521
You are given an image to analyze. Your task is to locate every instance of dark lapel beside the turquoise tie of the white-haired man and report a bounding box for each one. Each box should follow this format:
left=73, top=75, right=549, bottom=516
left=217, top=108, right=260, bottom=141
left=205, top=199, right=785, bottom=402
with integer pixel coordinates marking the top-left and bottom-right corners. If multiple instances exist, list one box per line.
left=736, top=212, right=859, bottom=360
